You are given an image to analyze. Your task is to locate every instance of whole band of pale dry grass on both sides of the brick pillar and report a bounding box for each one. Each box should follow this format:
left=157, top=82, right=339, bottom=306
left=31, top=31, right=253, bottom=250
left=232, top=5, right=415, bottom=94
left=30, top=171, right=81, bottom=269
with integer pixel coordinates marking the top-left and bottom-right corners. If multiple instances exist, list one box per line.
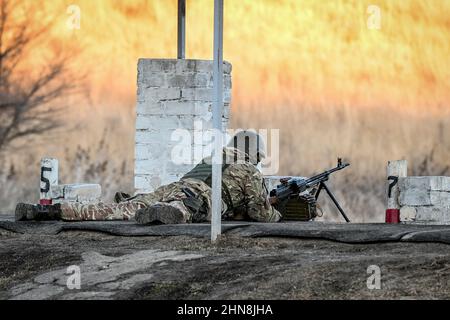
left=0, top=107, right=450, bottom=222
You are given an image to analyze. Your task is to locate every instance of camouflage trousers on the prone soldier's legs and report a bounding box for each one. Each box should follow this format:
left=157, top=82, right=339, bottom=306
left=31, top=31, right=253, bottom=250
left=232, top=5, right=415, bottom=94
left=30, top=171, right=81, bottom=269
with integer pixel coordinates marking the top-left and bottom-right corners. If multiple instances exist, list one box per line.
left=61, top=179, right=211, bottom=222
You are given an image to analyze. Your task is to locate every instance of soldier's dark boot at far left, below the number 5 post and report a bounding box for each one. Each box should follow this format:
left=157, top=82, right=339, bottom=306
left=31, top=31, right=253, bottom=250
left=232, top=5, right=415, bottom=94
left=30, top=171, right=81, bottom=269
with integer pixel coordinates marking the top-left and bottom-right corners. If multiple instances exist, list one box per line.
left=15, top=203, right=61, bottom=221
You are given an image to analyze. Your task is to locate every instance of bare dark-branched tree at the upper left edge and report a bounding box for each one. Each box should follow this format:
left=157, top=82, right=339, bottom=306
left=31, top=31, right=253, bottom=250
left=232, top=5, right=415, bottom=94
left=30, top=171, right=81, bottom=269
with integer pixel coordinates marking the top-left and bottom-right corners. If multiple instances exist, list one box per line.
left=0, top=0, right=79, bottom=152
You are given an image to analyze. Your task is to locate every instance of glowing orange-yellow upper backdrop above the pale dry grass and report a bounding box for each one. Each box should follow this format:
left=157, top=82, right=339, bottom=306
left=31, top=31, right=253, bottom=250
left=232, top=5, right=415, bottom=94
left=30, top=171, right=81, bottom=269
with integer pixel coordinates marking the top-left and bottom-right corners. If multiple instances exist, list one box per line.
left=28, top=0, right=450, bottom=110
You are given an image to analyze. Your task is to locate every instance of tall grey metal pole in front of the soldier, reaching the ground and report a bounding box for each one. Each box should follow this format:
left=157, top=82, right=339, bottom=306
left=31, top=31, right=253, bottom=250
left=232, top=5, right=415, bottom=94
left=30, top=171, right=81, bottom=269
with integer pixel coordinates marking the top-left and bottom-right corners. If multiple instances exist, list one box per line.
left=211, top=0, right=223, bottom=241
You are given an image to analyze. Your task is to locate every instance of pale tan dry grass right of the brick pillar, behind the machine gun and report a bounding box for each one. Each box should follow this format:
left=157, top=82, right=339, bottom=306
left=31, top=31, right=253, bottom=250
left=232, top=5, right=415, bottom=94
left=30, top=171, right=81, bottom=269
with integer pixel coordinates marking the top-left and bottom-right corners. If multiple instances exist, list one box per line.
left=233, top=107, right=450, bottom=222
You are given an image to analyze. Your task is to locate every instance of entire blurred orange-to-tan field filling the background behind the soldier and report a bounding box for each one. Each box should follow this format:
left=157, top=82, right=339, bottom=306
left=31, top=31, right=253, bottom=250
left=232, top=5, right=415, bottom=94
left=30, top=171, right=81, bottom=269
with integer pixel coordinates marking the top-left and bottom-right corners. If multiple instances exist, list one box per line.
left=0, top=0, right=450, bottom=221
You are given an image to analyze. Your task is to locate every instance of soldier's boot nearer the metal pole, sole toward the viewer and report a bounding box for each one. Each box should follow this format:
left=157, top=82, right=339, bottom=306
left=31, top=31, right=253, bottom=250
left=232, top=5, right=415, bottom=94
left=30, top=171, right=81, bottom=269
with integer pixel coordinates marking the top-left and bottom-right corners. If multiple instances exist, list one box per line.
left=134, top=203, right=186, bottom=224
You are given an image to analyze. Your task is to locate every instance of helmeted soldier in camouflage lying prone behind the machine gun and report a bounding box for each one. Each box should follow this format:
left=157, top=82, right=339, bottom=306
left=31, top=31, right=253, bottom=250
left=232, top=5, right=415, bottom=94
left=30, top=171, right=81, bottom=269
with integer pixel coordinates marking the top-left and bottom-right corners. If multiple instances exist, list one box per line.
left=16, top=131, right=281, bottom=224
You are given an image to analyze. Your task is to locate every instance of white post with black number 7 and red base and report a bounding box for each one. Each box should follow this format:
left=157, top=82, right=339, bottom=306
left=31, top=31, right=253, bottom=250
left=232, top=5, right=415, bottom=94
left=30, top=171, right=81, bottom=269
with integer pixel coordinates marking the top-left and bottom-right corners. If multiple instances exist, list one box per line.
left=386, top=160, right=408, bottom=223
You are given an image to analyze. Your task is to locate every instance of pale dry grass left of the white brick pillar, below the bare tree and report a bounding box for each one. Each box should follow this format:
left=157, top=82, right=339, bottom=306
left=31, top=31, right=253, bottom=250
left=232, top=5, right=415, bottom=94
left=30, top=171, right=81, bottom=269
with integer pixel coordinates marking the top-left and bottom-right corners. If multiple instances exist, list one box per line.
left=0, top=109, right=134, bottom=212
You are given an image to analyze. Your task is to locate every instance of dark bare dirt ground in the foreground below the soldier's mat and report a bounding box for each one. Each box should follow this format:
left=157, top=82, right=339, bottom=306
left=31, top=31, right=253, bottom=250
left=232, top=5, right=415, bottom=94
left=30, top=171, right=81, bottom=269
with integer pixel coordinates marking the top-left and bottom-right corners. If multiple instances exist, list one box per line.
left=0, top=231, right=450, bottom=299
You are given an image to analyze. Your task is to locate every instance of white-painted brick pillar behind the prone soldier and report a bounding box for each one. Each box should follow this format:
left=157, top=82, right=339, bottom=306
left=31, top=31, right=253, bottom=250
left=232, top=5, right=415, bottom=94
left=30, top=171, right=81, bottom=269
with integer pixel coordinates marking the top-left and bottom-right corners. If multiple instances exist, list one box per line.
left=135, top=59, right=231, bottom=192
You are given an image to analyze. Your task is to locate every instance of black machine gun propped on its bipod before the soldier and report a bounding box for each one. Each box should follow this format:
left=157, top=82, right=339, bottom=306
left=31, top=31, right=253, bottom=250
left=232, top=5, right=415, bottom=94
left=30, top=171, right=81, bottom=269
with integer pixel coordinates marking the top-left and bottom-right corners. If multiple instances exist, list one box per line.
left=270, top=158, right=350, bottom=222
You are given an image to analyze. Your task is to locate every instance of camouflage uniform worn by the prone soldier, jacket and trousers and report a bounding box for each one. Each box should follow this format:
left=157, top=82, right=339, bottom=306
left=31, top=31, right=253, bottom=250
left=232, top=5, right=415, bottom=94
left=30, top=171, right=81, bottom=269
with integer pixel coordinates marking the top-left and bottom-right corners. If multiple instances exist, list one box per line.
left=61, top=148, right=281, bottom=223
